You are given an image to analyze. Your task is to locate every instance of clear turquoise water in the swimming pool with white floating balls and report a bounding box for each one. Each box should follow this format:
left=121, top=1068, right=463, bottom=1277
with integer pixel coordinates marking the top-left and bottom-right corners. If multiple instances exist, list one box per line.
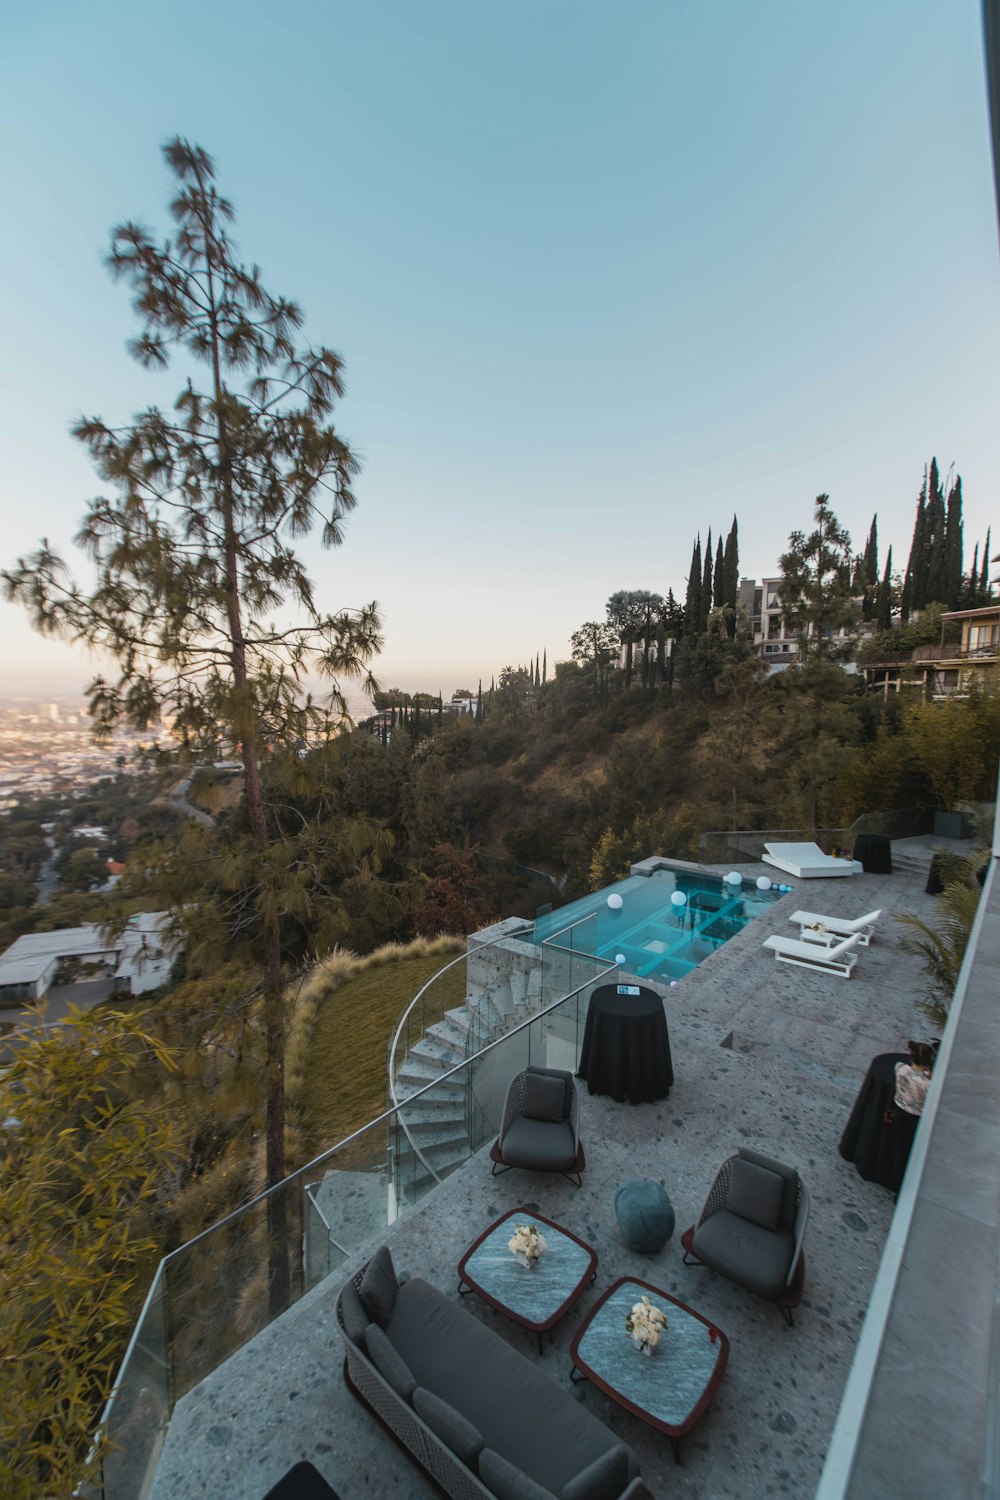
left=535, top=870, right=781, bottom=981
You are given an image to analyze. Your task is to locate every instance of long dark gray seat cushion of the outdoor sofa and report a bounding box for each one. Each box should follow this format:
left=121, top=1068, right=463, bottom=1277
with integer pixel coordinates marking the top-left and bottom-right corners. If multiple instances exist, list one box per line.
left=388, top=1271, right=639, bottom=1496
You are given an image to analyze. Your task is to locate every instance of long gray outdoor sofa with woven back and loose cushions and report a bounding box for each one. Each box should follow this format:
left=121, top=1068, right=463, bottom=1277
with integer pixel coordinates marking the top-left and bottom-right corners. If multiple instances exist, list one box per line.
left=337, top=1247, right=651, bottom=1500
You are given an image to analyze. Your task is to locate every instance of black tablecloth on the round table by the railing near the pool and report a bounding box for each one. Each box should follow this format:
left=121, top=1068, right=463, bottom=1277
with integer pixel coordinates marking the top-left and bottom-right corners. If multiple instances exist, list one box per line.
left=577, top=984, right=673, bottom=1104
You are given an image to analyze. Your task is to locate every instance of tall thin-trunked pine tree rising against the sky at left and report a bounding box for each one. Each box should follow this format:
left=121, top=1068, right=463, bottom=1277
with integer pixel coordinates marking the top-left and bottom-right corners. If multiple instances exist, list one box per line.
left=4, top=140, right=381, bottom=1311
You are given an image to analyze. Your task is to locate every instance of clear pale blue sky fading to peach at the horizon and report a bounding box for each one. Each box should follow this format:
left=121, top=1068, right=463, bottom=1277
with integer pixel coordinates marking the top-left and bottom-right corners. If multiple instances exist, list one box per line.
left=0, top=0, right=1000, bottom=698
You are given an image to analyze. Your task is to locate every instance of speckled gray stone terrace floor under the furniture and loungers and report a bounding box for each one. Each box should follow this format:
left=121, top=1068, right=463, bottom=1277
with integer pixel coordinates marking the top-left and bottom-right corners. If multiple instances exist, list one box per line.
left=151, top=840, right=953, bottom=1500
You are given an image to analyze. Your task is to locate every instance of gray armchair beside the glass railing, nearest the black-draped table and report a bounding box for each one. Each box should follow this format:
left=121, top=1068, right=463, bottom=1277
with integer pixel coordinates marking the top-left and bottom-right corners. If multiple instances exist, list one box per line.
left=490, top=1068, right=586, bottom=1188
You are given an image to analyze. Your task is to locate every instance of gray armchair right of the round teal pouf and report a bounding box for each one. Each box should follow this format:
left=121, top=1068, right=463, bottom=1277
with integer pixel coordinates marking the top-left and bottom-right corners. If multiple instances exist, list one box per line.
left=681, top=1148, right=810, bottom=1326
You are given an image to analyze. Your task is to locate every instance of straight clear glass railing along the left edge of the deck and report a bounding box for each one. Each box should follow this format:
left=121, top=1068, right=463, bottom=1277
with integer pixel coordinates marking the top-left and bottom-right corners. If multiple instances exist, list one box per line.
left=96, top=935, right=615, bottom=1500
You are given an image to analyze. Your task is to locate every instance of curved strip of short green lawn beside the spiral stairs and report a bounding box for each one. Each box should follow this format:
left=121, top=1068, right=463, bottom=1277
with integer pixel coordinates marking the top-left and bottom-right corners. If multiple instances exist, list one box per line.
left=301, top=953, right=465, bottom=1157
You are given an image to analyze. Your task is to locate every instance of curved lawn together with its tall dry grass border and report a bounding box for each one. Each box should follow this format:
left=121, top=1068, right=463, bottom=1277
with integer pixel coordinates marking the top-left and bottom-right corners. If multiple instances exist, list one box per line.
left=286, top=936, right=465, bottom=1163
